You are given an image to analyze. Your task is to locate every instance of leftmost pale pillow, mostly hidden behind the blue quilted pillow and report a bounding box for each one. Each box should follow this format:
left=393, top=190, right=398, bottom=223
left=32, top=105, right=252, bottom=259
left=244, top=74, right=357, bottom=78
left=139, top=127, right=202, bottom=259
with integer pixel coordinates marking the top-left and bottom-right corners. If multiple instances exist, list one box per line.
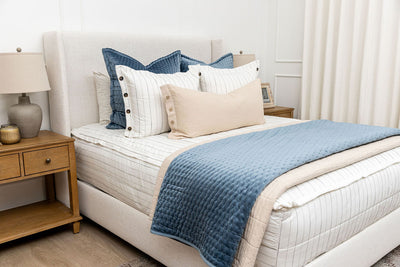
left=93, top=72, right=112, bottom=125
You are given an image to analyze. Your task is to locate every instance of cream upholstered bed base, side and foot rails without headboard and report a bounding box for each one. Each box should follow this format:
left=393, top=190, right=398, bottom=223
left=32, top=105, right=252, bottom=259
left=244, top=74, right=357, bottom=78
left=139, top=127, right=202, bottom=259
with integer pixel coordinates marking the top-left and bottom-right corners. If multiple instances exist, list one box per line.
left=78, top=181, right=400, bottom=267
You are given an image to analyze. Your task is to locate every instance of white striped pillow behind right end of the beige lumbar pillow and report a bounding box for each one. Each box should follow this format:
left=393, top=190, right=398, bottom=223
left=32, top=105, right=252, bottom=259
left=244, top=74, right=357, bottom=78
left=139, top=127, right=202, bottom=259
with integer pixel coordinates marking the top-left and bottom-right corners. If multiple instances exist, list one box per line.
left=189, top=60, right=260, bottom=94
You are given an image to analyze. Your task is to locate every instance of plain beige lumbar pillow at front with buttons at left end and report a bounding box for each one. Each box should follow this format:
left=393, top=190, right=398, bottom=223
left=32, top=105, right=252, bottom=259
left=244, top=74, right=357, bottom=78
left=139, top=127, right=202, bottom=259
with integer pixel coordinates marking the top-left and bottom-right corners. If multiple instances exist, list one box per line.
left=161, top=79, right=264, bottom=139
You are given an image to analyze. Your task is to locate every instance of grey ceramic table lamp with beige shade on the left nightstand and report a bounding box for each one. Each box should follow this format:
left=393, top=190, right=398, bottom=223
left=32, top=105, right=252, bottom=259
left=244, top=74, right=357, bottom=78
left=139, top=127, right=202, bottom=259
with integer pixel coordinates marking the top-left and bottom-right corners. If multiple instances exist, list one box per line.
left=0, top=48, right=50, bottom=138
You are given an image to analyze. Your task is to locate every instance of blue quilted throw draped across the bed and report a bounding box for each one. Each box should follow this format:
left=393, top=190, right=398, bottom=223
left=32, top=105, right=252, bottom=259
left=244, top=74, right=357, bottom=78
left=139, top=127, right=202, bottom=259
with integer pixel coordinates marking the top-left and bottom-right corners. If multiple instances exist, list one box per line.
left=151, top=120, right=400, bottom=266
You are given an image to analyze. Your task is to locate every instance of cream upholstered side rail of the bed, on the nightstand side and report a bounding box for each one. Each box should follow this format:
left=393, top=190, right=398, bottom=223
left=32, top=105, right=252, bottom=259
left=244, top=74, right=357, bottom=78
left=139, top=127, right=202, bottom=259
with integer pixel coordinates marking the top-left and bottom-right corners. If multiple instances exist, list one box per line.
left=78, top=181, right=207, bottom=266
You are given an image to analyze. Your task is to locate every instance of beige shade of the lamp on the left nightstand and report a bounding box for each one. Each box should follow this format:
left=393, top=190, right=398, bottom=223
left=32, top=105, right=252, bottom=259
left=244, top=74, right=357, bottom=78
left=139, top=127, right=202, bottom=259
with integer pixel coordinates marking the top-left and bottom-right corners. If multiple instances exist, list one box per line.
left=0, top=53, right=50, bottom=94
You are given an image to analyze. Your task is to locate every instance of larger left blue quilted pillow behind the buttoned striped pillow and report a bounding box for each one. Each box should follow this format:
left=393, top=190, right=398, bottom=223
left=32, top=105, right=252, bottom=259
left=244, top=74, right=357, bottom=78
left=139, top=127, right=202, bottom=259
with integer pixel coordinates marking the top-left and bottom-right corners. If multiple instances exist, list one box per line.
left=102, top=48, right=181, bottom=129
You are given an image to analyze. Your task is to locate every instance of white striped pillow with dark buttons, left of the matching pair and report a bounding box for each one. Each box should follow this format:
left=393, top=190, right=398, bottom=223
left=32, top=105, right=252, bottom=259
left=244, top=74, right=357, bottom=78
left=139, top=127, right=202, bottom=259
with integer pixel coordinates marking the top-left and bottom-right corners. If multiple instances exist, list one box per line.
left=116, top=65, right=199, bottom=137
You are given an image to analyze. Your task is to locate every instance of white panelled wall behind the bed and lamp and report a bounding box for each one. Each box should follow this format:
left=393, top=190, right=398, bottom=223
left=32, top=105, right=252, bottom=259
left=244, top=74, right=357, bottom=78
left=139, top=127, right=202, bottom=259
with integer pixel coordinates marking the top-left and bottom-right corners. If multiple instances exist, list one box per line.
left=0, top=0, right=304, bottom=210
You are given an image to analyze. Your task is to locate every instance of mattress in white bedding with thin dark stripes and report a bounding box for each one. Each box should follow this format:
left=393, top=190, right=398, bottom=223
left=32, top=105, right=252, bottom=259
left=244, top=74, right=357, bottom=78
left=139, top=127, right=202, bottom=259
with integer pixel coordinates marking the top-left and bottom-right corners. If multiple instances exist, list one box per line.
left=72, top=116, right=400, bottom=266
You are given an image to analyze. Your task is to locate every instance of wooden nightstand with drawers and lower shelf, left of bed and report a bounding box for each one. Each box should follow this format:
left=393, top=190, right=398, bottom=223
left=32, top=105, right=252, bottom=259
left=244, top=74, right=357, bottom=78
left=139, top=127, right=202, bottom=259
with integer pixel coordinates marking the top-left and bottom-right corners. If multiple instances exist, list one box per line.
left=0, top=131, right=82, bottom=244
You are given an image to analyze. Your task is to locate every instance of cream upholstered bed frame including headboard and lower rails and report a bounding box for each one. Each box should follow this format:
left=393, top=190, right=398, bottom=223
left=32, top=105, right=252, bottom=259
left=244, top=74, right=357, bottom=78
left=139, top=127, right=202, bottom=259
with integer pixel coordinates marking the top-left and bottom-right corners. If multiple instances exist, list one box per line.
left=43, top=32, right=400, bottom=266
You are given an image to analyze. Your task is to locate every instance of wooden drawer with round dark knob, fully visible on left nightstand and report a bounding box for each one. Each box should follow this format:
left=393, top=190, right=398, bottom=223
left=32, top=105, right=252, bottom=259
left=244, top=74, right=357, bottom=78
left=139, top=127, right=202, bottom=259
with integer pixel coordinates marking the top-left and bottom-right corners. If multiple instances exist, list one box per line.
left=23, top=146, right=69, bottom=175
